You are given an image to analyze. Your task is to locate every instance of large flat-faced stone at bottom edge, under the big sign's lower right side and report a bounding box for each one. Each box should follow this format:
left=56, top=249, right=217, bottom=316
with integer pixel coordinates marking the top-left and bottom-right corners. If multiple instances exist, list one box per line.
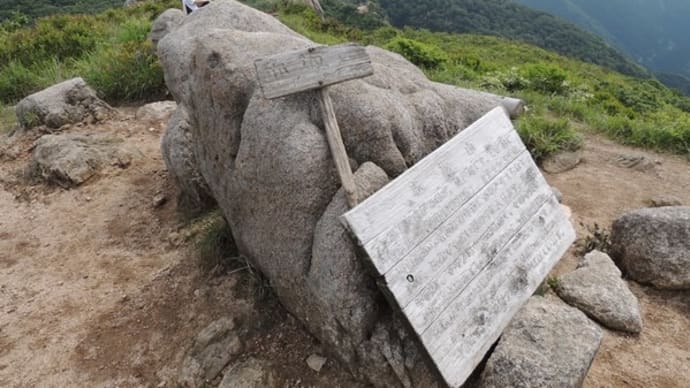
left=479, top=297, right=603, bottom=388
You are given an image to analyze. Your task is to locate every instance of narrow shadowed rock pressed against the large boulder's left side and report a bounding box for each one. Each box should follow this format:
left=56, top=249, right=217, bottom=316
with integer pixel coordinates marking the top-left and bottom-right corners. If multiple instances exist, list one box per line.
left=161, top=107, right=216, bottom=216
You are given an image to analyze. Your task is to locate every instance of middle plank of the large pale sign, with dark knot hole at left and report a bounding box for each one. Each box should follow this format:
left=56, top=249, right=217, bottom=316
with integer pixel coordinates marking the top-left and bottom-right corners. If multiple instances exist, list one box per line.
left=385, top=152, right=552, bottom=316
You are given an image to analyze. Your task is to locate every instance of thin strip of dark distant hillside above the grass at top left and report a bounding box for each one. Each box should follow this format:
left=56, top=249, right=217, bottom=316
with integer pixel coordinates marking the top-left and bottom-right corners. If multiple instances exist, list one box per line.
left=0, top=0, right=124, bottom=21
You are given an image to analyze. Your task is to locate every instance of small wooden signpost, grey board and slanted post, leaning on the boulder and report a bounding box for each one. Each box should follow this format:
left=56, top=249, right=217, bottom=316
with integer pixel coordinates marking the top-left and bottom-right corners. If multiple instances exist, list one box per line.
left=254, top=44, right=374, bottom=208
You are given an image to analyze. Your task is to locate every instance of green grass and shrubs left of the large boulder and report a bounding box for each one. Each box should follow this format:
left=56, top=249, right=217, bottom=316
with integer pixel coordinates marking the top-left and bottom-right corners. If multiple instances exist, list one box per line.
left=0, top=0, right=178, bottom=104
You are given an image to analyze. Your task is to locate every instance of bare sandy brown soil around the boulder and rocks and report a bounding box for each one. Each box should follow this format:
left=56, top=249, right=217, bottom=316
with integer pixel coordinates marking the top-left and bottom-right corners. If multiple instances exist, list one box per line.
left=0, top=109, right=690, bottom=387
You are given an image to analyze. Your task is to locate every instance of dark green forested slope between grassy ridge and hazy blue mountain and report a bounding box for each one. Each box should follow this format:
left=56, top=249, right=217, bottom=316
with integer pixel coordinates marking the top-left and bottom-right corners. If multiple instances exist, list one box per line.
left=379, top=0, right=648, bottom=77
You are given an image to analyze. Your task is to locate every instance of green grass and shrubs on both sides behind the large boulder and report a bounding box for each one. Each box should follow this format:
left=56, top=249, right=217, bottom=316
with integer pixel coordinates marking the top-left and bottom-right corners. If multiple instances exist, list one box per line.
left=0, top=0, right=690, bottom=160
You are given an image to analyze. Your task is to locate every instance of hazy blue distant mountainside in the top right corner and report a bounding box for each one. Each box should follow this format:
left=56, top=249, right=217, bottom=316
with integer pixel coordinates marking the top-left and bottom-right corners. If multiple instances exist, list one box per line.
left=515, top=0, right=690, bottom=82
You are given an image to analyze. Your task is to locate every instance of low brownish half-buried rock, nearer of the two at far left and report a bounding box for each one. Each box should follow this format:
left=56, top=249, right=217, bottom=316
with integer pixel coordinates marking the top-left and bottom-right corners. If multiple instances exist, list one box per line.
left=30, top=133, right=141, bottom=187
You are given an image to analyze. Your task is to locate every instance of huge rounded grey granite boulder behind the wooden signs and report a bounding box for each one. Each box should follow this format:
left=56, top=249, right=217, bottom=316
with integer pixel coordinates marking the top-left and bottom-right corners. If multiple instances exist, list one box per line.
left=158, top=0, right=521, bottom=387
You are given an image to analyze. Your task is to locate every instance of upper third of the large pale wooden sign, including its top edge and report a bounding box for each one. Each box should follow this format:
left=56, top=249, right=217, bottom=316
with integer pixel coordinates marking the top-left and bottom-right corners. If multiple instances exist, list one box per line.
left=342, top=108, right=525, bottom=268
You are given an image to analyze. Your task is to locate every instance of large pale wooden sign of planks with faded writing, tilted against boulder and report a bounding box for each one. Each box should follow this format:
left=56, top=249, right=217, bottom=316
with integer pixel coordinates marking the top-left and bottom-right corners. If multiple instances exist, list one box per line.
left=342, top=108, right=575, bottom=387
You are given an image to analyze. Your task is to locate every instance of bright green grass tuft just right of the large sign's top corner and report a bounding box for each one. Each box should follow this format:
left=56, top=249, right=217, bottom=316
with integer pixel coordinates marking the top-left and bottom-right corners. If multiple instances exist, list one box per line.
left=518, top=116, right=582, bottom=162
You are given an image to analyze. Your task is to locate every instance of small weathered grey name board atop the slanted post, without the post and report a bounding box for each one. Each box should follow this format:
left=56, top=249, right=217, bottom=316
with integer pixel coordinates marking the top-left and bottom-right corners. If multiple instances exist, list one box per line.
left=254, top=43, right=374, bottom=99
